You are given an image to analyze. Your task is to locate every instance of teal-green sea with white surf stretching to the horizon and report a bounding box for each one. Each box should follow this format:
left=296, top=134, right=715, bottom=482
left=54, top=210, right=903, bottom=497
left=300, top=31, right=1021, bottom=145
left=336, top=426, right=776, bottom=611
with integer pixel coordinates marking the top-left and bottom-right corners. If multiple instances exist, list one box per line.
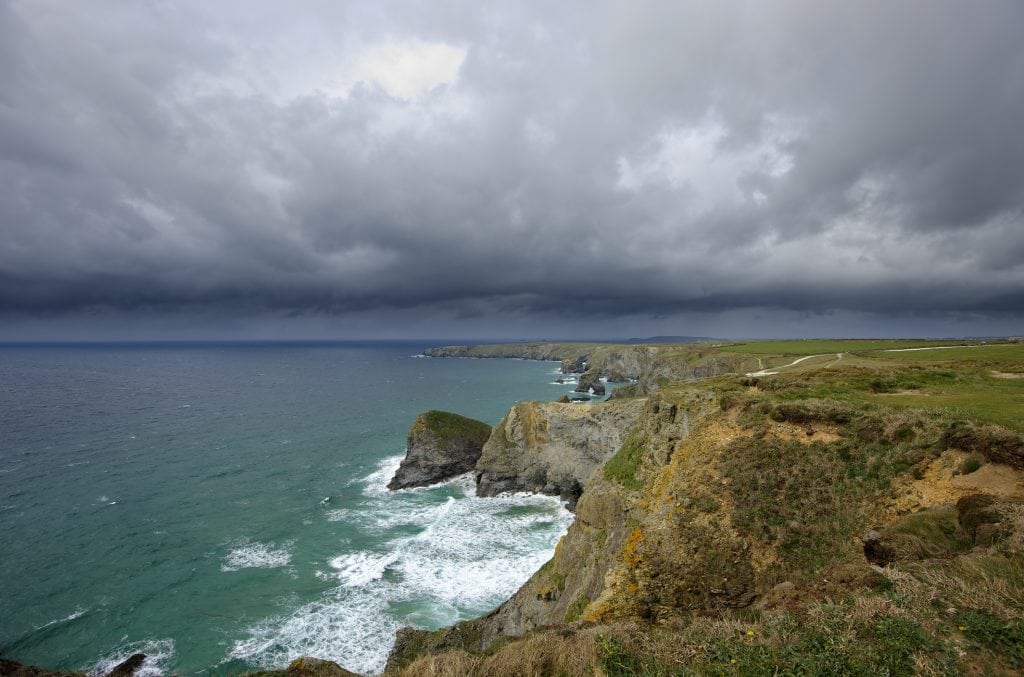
left=0, top=343, right=572, bottom=675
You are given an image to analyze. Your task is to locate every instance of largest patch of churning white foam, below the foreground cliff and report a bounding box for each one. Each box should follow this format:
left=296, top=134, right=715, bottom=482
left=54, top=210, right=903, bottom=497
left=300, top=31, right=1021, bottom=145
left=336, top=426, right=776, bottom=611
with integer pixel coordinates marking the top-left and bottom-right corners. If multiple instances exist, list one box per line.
left=228, top=457, right=572, bottom=674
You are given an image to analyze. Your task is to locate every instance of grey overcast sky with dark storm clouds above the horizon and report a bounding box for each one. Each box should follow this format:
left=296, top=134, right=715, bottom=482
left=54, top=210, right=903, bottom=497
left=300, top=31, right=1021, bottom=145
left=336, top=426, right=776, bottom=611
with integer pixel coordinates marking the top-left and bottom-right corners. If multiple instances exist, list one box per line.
left=0, top=0, right=1024, bottom=339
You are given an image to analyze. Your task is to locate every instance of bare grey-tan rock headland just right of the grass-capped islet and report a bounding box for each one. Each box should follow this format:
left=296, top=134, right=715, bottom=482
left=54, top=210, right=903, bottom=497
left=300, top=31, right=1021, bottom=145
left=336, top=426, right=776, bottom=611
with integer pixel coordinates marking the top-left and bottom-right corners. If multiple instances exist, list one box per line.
left=476, top=399, right=643, bottom=507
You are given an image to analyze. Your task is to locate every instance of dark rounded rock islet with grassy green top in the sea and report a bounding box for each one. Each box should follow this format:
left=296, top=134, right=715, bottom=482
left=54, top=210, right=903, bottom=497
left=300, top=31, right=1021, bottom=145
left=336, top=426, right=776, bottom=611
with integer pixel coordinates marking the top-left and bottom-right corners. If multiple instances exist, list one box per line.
left=387, top=411, right=490, bottom=491
